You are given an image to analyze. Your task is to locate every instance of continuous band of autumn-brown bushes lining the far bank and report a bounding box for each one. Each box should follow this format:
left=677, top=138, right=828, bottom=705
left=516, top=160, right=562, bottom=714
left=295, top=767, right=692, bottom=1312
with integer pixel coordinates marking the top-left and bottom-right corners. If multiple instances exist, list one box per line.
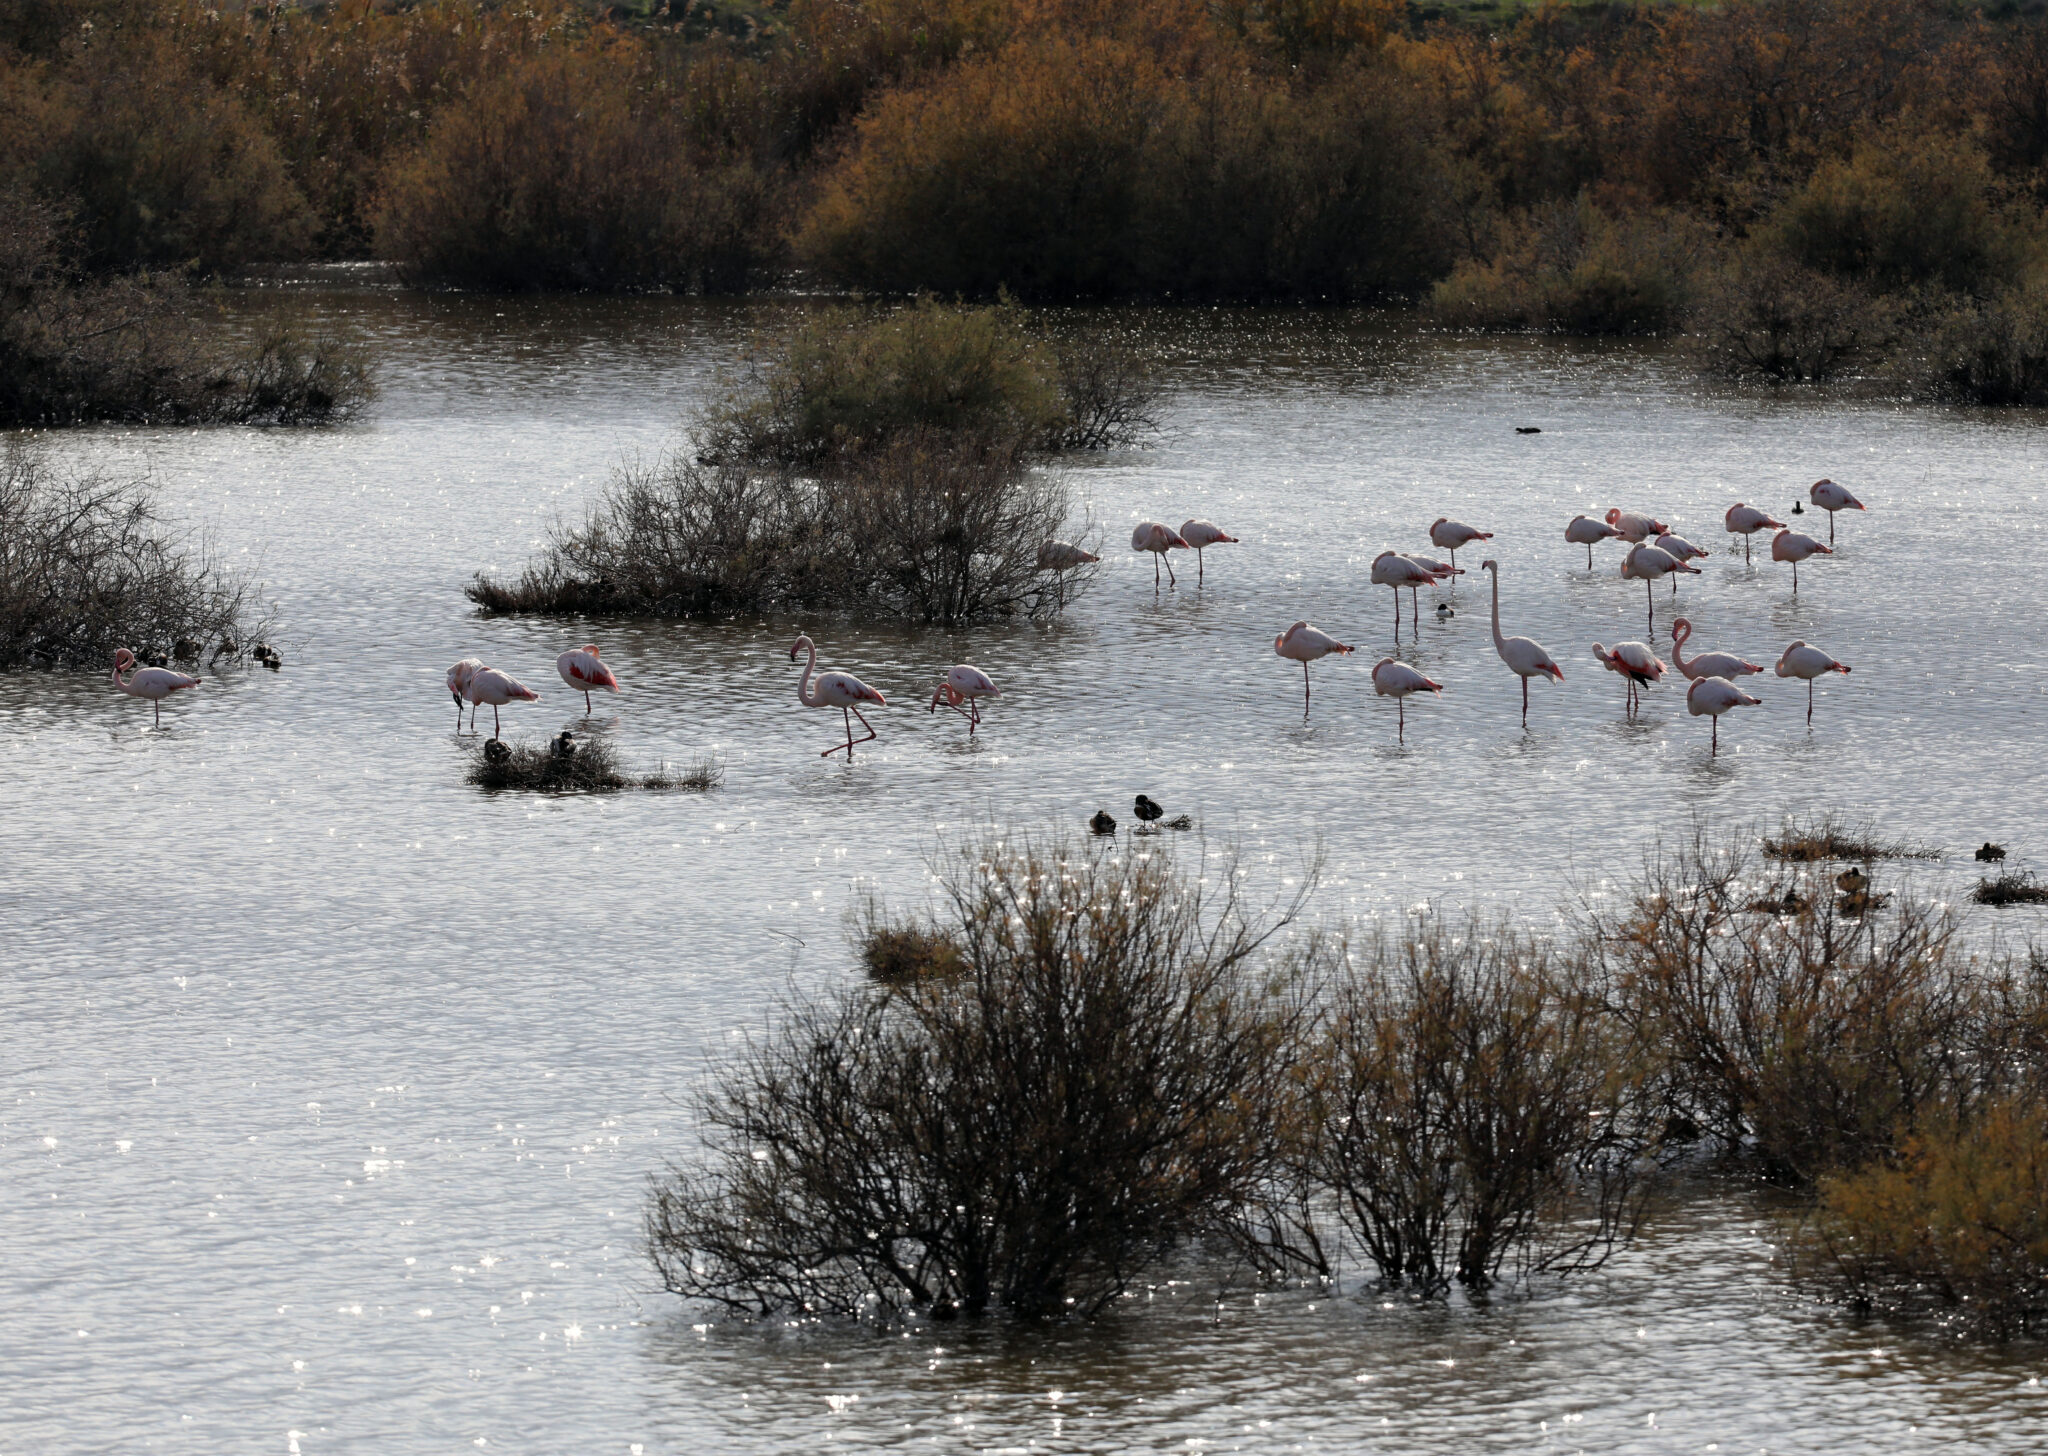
left=0, top=0, right=2048, bottom=403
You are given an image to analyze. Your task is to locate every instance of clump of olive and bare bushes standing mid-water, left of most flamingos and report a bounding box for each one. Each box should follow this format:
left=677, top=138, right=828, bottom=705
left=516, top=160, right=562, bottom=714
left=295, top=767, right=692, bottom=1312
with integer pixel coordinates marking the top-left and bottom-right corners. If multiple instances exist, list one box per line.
left=469, top=297, right=1130, bottom=625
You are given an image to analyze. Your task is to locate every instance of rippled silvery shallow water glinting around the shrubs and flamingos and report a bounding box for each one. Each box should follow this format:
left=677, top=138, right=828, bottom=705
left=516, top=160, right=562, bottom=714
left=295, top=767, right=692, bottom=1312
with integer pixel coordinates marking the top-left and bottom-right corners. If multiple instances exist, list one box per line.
left=0, top=291, right=2048, bottom=1456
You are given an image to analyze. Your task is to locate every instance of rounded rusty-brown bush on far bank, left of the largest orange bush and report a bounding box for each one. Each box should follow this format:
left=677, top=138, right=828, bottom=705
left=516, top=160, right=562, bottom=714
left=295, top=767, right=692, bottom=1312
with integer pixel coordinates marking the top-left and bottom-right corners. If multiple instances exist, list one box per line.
left=377, top=45, right=778, bottom=293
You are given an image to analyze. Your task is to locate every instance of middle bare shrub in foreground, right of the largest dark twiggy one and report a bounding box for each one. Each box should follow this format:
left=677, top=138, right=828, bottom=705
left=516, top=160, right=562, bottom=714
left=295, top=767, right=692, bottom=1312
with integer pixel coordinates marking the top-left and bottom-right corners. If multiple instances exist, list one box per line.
left=1253, top=917, right=1655, bottom=1294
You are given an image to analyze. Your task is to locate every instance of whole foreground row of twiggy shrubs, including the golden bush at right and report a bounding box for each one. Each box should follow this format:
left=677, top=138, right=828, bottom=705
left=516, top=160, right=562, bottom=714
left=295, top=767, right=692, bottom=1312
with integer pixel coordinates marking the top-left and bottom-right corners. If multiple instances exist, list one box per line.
left=647, top=823, right=2048, bottom=1335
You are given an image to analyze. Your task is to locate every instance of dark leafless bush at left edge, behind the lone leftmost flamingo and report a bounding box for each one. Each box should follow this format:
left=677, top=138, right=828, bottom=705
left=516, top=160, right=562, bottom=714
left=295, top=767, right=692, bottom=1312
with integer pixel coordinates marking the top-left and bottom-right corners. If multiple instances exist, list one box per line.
left=0, top=440, right=264, bottom=668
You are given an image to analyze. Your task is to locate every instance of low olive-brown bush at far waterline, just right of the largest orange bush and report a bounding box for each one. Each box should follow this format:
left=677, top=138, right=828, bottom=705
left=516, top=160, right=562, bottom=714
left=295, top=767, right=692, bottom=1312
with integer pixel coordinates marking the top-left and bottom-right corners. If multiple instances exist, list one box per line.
left=1430, top=195, right=1706, bottom=334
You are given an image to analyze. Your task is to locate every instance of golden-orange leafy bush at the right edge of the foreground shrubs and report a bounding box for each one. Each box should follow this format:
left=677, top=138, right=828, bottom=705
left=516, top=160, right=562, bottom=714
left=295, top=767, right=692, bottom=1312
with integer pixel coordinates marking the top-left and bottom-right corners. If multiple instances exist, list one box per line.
left=1804, top=1100, right=2048, bottom=1335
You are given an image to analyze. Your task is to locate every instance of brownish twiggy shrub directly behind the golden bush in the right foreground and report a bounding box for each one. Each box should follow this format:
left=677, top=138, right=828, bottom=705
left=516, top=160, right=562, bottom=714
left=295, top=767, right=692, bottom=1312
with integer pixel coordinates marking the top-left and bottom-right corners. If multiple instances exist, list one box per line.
left=1581, top=829, right=1985, bottom=1184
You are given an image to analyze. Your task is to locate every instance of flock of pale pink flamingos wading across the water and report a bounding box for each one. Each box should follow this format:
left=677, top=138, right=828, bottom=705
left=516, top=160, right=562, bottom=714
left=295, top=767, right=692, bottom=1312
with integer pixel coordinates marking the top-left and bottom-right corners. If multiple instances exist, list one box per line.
left=115, top=479, right=1864, bottom=760
